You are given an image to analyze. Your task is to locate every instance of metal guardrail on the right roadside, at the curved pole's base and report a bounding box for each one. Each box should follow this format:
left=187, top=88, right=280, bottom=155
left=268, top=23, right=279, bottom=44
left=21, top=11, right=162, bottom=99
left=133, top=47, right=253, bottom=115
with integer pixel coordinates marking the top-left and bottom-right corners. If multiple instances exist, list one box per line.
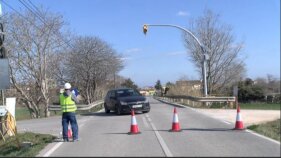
left=155, top=95, right=236, bottom=102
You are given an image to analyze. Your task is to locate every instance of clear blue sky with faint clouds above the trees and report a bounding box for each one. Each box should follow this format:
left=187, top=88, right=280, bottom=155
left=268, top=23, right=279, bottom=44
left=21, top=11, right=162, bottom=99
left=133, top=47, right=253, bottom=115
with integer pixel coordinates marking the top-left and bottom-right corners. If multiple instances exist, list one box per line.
left=0, top=0, right=280, bottom=87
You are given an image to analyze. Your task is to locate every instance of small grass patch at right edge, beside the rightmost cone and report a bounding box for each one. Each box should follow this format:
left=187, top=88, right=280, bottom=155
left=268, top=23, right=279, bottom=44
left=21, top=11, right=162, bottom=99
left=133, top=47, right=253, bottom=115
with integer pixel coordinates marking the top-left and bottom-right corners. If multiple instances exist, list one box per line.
left=247, top=119, right=281, bottom=142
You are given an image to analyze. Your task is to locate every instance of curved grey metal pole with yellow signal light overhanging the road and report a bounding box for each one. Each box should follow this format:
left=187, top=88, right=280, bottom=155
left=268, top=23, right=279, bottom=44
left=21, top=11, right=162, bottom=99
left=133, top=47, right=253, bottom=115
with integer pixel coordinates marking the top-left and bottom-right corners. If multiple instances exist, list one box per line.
left=143, top=24, right=209, bottom=97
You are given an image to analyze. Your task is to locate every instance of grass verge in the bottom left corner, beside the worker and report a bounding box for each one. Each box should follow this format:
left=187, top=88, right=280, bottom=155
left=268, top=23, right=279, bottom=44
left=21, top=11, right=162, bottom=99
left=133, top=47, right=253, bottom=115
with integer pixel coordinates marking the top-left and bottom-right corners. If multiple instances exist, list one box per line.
left=0, top=132, right=56, bottom=157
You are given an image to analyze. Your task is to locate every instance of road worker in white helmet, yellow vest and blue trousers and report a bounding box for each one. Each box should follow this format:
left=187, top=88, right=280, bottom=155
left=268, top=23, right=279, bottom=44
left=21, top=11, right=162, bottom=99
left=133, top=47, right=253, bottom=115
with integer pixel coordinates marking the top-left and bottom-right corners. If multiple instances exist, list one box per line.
left=60, top=83, right=78, bottom=142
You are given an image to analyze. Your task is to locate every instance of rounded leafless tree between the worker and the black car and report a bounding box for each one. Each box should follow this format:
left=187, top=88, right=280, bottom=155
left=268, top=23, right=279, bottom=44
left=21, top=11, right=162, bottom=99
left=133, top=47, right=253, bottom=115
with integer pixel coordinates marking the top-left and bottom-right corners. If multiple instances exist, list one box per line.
left=66, top=37, right=123, bottom=104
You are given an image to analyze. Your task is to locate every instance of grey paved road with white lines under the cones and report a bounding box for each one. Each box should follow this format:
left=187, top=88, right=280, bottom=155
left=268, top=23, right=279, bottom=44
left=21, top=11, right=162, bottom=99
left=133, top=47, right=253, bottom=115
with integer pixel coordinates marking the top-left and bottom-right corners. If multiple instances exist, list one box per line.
left=17, top=98, right=280, bottom=157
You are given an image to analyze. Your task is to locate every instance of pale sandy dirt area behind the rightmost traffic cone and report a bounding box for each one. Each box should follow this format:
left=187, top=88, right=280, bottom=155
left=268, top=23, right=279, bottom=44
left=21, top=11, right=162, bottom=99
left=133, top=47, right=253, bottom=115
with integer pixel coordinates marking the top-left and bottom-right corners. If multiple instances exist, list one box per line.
left=195, top=109, right=280, bottom=126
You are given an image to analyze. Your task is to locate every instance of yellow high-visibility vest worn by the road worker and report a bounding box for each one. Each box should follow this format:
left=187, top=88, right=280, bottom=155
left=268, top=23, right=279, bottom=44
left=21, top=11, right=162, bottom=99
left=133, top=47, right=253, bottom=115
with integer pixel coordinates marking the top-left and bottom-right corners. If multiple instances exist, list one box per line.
left=60, top=93, right=77, bottom=112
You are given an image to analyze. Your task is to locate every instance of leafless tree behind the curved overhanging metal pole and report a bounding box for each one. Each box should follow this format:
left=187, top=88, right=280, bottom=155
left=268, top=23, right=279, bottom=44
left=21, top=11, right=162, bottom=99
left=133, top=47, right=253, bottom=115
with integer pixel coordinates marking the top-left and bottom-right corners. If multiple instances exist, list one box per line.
left=184, top=10, right=245, bottom=94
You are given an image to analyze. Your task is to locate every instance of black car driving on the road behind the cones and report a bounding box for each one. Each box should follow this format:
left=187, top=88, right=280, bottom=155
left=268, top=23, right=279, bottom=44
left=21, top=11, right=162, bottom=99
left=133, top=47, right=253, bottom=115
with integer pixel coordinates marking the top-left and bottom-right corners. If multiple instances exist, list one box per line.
left=104, top=88, right=150, bottom=115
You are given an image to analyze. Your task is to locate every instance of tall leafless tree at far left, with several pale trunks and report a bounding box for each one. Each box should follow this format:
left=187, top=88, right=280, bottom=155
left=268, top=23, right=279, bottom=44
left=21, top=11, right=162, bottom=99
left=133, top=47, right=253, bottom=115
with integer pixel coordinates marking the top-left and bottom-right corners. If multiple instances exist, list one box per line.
left=5, top=9, right=64, bottom=118
